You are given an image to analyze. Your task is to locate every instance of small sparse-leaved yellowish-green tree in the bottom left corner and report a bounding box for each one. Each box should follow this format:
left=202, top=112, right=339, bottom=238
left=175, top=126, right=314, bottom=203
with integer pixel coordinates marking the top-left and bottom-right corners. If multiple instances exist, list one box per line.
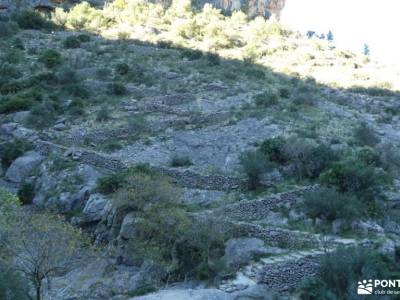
left=1, top=213, right=86, bottom=300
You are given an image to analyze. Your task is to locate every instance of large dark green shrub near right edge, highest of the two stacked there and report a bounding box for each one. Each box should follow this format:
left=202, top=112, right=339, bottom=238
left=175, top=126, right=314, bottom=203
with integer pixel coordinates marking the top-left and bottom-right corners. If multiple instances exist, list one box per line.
left=320, top=158, right=391, bottom=201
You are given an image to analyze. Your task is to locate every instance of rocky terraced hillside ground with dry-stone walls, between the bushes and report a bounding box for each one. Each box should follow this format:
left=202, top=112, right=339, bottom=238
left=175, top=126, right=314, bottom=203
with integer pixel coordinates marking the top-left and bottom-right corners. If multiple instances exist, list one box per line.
left=0, top=1, right=400, bottom=300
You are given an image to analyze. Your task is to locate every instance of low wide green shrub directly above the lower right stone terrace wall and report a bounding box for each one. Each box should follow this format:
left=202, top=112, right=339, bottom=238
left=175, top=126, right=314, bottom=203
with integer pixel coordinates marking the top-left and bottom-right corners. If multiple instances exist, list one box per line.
left=300, top=187, right=367, bottom=222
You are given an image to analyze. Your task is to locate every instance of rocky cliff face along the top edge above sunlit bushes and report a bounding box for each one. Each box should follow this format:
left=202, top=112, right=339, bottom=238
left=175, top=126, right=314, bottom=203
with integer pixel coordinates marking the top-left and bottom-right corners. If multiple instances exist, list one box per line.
left=0, top=0, right=286, bottom=19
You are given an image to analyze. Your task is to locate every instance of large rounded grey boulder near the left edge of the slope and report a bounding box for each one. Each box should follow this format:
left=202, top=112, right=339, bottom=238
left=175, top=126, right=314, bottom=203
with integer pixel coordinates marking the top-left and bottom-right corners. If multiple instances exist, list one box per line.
left=6, top=151, right=43, bottom=183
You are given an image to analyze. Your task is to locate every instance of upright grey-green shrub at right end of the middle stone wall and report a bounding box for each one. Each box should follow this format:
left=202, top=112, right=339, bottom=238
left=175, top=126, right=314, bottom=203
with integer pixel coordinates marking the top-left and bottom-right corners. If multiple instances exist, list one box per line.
left=240, top=151, right=269, bottom=190
